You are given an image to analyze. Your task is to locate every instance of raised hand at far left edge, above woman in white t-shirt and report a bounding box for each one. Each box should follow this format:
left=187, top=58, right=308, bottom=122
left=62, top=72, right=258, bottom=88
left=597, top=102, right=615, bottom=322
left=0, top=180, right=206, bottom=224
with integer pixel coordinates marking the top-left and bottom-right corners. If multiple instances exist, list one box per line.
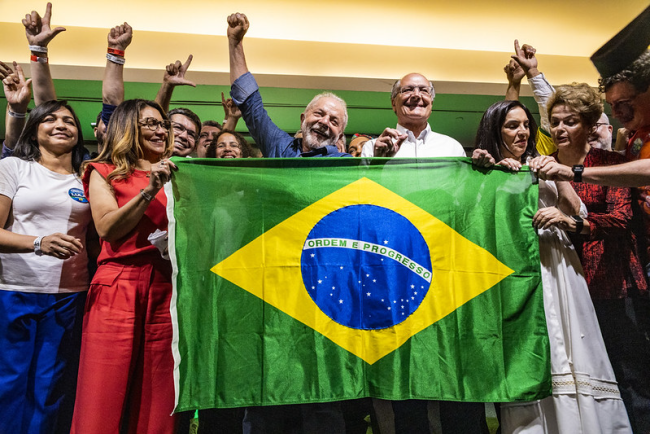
left=0, top=62, right=32, bottom=150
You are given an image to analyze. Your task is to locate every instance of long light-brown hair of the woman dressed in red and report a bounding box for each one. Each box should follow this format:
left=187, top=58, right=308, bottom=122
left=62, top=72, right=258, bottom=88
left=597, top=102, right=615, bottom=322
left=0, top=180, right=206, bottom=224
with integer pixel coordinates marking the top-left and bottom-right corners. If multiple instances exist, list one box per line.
left=90, top=99, right=174, bottom=182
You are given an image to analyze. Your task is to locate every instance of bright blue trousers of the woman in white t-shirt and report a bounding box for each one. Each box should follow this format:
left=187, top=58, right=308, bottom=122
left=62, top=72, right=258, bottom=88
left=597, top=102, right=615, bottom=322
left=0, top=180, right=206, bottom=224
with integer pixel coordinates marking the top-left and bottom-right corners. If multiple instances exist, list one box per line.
left=0, top=290, right=86, bottom=434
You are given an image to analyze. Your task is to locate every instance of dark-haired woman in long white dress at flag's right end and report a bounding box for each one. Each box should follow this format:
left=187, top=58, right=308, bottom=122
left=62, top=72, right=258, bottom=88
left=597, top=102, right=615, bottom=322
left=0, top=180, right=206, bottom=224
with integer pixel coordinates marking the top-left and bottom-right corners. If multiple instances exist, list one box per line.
left=473, top=101, right=632, bottom=434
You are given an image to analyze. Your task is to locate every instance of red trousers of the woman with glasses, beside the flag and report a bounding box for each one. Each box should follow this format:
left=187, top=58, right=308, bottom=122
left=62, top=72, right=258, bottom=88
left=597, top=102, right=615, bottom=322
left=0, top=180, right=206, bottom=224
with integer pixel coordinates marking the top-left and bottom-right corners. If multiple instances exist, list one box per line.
left=71, top=261, right=177, bottom=434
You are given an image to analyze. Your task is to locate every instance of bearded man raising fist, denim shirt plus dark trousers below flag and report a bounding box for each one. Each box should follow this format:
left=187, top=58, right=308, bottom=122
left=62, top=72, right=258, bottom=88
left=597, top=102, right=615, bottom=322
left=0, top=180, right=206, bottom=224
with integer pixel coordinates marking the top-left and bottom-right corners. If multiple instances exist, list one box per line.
left=227, top=13, right=350, bottom=434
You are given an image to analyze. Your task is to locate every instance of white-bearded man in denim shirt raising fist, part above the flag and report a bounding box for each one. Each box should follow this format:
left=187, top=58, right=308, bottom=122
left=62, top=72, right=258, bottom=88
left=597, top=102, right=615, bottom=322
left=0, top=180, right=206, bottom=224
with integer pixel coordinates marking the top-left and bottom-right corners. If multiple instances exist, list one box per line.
left=228, top=13, right=350, bottom=157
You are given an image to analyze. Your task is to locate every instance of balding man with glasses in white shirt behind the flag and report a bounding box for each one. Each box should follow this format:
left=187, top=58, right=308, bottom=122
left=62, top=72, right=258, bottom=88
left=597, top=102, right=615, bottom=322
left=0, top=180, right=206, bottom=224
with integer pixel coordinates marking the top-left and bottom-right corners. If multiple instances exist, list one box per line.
left=361, top=73, right=466, bottom=158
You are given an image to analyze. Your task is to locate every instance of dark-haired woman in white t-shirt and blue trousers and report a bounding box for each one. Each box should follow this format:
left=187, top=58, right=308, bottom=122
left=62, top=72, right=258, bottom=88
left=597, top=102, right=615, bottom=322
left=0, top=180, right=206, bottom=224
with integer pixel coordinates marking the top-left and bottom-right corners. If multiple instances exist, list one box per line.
left=0, top=98, right=91, bottom=433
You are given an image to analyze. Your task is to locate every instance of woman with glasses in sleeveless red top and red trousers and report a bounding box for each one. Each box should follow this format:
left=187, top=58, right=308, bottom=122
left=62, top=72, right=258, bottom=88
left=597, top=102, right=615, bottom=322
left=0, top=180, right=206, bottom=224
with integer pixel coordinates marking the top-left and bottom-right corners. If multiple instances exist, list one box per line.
left=72, top=99, right=176, bottom=434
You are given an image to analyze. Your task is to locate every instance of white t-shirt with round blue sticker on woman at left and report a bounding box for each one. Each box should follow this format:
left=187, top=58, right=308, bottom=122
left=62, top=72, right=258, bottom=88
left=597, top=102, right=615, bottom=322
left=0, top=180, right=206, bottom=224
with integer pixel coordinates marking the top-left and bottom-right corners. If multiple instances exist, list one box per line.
left=0, top=157, right=91, bottom=294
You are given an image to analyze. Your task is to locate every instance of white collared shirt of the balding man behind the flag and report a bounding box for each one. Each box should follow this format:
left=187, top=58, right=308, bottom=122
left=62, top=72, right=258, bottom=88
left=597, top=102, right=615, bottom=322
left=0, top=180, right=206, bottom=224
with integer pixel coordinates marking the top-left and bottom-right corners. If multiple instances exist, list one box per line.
left=361, top=124, right=467, bottom=158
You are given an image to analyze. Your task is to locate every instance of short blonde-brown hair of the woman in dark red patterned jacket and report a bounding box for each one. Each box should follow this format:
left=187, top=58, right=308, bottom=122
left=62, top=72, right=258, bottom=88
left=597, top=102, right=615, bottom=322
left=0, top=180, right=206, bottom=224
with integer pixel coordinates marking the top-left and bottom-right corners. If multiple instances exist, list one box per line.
left=547, top=83, right=603, bottom=128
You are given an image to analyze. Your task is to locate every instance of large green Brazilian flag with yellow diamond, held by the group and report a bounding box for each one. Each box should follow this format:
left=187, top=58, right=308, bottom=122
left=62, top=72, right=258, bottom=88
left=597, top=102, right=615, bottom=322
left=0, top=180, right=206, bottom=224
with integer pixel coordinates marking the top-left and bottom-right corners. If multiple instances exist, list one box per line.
left=166, top=158, right=551, bottom=411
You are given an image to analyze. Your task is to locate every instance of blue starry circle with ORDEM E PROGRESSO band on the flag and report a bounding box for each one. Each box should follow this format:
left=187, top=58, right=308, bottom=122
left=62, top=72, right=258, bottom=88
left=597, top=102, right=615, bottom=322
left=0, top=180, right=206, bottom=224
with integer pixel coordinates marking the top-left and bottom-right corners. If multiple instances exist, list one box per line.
left=301, top=205, right=431, bottom=330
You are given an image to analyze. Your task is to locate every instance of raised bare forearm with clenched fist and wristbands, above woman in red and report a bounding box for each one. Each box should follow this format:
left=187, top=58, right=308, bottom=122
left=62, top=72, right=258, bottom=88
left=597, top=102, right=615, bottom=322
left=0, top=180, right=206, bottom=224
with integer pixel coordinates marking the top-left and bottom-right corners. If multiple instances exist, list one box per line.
left=102, top=22, right=133, bottom=106
